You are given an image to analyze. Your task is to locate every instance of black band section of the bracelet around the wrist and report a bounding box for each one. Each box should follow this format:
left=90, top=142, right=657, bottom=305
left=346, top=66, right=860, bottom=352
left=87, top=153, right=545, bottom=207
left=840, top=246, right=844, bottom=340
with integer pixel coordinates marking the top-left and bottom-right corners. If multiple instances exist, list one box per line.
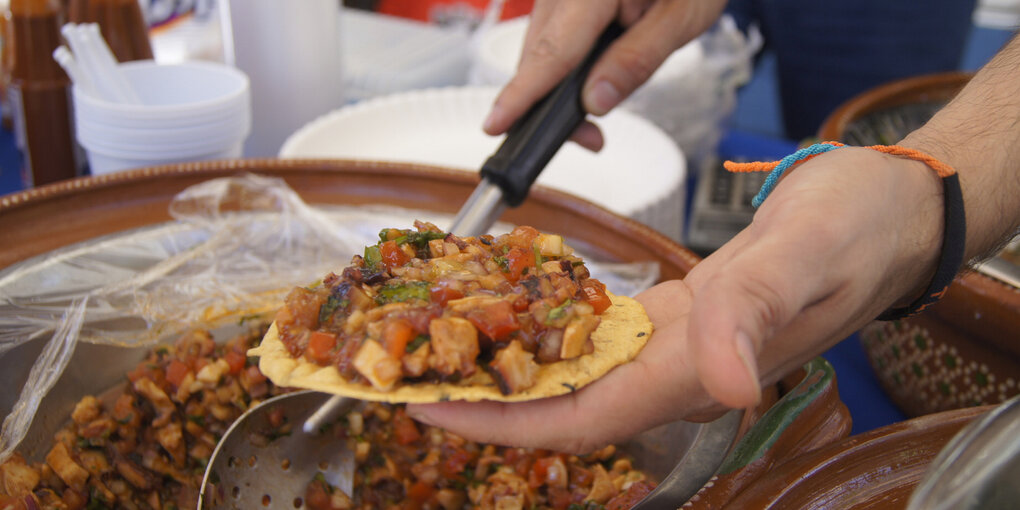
left=878, top=173, right=967, bottom=320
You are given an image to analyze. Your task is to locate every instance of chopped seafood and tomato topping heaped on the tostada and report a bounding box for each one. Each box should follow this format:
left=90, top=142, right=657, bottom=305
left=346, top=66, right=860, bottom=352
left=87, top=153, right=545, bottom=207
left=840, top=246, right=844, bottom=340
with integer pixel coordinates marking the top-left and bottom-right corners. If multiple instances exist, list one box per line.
left=275, top=221, right=612, bottom=395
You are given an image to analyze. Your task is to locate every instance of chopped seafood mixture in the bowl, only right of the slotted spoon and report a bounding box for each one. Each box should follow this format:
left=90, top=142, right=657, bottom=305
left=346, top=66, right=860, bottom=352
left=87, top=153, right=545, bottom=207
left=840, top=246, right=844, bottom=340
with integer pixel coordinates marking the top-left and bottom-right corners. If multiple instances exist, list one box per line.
left=304, top=403, right=655, bottom=510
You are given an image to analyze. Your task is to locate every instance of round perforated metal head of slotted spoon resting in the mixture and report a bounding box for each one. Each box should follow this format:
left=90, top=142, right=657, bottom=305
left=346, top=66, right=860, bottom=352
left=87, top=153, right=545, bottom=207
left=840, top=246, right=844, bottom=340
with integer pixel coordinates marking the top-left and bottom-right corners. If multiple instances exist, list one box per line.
left=198, top=392, right=357, bottom=509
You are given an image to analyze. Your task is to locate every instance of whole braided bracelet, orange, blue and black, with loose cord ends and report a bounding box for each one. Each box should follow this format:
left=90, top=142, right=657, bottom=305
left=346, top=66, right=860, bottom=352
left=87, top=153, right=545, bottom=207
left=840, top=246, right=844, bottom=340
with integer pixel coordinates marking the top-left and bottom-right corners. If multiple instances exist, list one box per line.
left=723, top=142, right=967, bottom=320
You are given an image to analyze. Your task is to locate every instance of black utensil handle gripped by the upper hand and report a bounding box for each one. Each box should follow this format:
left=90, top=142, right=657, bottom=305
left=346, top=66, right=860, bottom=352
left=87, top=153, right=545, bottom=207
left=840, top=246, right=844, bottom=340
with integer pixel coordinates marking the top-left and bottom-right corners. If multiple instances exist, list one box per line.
left=481, top=21, right=623, bottom=207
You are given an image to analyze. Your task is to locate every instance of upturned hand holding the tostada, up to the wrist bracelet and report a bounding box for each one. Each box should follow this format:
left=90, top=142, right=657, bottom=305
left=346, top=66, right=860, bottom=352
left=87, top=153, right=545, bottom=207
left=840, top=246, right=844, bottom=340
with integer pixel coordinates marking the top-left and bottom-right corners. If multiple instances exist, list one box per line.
left=408, top=148, right=941, bottom=452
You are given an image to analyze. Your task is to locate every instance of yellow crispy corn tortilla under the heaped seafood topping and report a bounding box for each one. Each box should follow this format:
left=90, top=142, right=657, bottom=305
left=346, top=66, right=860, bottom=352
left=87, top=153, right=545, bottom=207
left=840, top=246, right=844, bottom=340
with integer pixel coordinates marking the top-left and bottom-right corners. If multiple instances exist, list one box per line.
left=248, top=293, right=653, bottom=404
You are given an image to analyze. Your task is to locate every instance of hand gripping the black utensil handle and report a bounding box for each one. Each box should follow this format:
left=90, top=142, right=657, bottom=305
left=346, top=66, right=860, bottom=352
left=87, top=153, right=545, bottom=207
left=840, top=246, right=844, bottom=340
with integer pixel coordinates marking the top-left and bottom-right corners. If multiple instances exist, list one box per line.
left=482, top=0, right=725, bottom=150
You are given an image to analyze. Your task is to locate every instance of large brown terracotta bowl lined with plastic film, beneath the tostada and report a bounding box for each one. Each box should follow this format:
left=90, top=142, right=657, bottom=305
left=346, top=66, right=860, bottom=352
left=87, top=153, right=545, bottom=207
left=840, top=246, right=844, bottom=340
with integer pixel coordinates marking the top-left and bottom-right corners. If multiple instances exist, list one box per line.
left=0, top=159, right=850, bottom=508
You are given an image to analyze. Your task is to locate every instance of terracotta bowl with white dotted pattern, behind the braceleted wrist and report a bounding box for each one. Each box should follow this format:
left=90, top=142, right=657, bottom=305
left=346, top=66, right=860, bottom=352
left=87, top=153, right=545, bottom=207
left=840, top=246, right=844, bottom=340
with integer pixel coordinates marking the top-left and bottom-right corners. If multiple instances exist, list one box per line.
left=818, top=72, right=1020, bottom=416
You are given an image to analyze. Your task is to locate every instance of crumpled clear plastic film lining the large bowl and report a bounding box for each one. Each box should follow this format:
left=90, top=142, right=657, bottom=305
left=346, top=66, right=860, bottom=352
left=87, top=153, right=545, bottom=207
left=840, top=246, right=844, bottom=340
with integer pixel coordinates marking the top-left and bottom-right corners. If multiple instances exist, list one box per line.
left=0, top=174, right=659, bottom=462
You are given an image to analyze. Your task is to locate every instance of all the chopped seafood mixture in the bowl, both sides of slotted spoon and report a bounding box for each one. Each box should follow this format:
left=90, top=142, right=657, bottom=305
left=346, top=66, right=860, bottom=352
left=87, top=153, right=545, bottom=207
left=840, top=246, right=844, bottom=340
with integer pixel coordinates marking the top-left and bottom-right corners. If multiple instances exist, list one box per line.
left=0, top=325, right=655, bottom=510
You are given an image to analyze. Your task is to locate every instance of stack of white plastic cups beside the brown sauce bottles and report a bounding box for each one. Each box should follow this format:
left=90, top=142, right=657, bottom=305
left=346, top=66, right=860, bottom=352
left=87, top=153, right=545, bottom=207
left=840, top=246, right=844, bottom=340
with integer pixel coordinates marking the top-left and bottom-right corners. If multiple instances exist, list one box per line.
left=73, top=60, right=252, bottom=174
